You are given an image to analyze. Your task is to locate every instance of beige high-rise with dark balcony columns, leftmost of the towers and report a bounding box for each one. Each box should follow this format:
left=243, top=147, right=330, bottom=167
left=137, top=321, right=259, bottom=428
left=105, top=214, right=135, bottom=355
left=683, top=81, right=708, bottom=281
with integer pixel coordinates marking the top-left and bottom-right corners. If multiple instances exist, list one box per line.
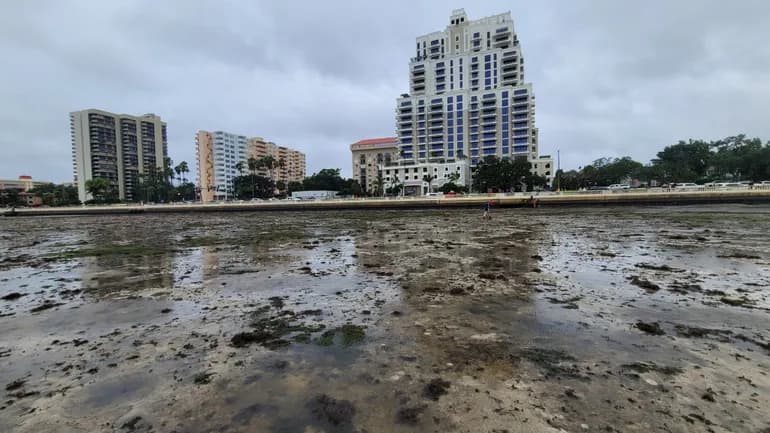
left=70, top=109, right=168, bottom=201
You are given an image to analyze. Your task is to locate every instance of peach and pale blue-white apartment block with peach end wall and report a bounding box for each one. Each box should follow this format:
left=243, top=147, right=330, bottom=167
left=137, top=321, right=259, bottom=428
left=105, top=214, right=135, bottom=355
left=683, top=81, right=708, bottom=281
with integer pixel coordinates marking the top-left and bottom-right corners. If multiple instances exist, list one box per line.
left=195, top=131, right=305, bottom=203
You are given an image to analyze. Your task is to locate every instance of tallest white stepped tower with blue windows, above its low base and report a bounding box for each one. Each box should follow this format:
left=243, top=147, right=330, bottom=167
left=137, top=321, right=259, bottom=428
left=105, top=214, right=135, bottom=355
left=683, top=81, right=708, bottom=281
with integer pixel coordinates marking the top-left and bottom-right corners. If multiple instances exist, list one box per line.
left=396, top=9, right=539, bottom=183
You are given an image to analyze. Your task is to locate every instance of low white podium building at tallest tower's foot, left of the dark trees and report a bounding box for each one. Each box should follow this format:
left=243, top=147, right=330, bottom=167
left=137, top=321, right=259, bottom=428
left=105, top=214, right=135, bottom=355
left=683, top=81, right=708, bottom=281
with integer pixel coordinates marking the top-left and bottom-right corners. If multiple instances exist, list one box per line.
left=383, top=158, right=471, bottom=195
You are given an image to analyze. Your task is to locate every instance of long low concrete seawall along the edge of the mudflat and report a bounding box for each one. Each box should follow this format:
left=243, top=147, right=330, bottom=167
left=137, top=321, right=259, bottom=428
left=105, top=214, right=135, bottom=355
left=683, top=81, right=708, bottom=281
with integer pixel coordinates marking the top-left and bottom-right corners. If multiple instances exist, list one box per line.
left=3, top=189, right=770, bottom=216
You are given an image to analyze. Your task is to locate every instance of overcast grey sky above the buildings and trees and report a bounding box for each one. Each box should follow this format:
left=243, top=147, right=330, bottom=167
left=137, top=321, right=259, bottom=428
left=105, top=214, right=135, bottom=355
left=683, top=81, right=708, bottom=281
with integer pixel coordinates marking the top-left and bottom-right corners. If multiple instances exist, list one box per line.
left=0, top=0, right=770, bottom=182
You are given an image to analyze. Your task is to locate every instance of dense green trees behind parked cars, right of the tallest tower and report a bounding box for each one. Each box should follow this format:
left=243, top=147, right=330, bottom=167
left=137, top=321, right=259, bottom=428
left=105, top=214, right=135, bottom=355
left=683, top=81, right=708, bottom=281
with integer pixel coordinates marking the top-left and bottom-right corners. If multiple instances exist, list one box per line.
left=554, top=135, right=770, bottom=190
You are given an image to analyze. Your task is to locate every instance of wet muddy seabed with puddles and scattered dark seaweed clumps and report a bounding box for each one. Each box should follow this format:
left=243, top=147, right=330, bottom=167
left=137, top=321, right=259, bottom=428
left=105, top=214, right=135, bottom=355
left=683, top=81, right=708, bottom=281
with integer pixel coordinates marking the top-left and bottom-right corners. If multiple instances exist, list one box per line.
left=0, top=206, right=770, bottom=433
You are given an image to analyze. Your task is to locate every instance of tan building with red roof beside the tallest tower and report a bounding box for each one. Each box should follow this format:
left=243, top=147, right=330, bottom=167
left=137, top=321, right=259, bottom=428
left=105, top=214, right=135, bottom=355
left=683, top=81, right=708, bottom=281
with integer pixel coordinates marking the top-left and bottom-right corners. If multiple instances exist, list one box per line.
left=350, top=137, right=398, bottom=194
